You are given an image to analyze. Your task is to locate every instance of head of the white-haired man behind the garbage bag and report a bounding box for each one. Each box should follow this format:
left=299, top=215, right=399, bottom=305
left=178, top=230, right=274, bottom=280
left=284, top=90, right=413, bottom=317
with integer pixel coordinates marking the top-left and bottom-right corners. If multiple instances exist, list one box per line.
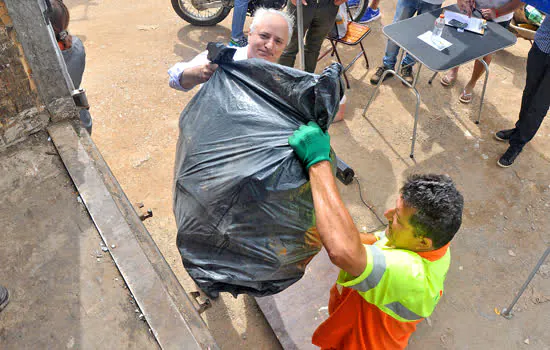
left=248, top=8, right=294, bottom=63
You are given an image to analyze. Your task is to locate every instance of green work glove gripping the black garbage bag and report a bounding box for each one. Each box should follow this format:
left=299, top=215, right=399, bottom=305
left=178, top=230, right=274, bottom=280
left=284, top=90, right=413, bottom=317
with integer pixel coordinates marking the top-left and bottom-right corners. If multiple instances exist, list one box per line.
left=288, top=122, right=330, bottom=169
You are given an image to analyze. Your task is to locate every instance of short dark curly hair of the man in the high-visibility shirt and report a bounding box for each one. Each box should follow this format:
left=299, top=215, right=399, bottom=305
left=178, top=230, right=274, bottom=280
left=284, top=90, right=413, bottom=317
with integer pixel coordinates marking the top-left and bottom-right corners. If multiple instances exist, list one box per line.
left=401, top=174, right=464, bottom=249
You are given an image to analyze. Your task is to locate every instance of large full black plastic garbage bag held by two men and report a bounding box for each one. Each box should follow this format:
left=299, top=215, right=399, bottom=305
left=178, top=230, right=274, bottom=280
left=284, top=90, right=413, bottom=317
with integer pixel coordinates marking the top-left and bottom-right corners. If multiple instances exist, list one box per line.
left=174, top=42, right=342, bottom=297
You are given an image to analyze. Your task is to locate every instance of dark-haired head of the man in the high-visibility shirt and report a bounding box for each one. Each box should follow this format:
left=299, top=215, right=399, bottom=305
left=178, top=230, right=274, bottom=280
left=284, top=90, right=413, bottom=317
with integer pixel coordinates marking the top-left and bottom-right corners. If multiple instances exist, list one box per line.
left=384, top=174, right=464, bottom=251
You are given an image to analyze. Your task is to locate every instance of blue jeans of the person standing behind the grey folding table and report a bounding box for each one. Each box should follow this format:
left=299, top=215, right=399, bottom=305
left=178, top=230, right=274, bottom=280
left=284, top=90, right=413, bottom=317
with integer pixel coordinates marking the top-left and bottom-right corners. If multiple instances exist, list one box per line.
left=383, top=0, right=441, bottom=69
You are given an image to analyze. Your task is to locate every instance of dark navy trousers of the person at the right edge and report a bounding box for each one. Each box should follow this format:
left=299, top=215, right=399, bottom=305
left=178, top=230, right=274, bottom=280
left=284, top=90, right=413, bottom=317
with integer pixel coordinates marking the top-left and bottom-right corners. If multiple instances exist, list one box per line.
left=510, top=43, right=550, bottom=148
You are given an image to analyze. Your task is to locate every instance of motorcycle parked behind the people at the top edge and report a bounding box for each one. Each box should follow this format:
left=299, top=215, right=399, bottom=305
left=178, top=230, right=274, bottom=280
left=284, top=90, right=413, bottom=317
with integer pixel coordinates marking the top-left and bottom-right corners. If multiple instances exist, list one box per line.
left=171, top=0, right=369, bottom=26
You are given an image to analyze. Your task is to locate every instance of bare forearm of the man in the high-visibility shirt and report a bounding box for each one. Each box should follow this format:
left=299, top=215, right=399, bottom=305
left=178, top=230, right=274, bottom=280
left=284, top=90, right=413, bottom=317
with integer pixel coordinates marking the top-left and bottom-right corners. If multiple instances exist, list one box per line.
left=309, top=161, right=367, bottom=276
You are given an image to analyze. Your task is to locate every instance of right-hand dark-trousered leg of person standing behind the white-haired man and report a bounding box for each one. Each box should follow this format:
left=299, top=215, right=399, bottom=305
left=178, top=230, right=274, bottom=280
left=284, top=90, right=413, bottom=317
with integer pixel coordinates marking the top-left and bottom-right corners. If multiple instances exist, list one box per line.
left=304, top=0, right=338, bottom=73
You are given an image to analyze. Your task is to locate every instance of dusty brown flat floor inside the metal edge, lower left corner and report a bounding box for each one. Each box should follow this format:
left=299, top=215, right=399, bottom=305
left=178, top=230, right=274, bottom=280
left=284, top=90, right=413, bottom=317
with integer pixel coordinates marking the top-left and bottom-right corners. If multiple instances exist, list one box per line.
left=0, top=132, right=158, bottom=349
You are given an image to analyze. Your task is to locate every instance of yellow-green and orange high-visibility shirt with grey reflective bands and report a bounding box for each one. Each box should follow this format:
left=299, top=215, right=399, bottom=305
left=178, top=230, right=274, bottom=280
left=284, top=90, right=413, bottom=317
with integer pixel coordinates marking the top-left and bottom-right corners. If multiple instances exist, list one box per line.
left=312, top=232, right=451, bottom=350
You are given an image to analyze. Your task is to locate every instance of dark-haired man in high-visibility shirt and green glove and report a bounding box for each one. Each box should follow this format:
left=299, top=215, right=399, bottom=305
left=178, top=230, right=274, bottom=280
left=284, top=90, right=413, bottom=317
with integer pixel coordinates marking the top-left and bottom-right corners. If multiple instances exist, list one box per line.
left=289, top=122, right=464, bottom=350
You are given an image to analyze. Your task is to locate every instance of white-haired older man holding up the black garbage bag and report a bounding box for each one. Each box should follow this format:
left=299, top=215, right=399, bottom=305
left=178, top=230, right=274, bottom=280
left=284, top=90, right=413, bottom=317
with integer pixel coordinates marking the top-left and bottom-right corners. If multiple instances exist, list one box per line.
left=168, top=8, right=294, bottom=91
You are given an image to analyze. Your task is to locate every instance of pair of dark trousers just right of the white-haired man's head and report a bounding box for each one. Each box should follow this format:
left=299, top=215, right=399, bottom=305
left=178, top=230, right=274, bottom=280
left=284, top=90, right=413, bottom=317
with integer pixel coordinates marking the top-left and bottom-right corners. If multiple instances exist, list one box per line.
left=279, top=0, right=338, bottom=73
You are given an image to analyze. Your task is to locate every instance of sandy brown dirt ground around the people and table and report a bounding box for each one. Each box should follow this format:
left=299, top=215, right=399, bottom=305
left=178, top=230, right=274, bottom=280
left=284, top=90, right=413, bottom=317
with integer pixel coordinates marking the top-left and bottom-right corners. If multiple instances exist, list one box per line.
left=65, top=0, right=550, bottom=349
